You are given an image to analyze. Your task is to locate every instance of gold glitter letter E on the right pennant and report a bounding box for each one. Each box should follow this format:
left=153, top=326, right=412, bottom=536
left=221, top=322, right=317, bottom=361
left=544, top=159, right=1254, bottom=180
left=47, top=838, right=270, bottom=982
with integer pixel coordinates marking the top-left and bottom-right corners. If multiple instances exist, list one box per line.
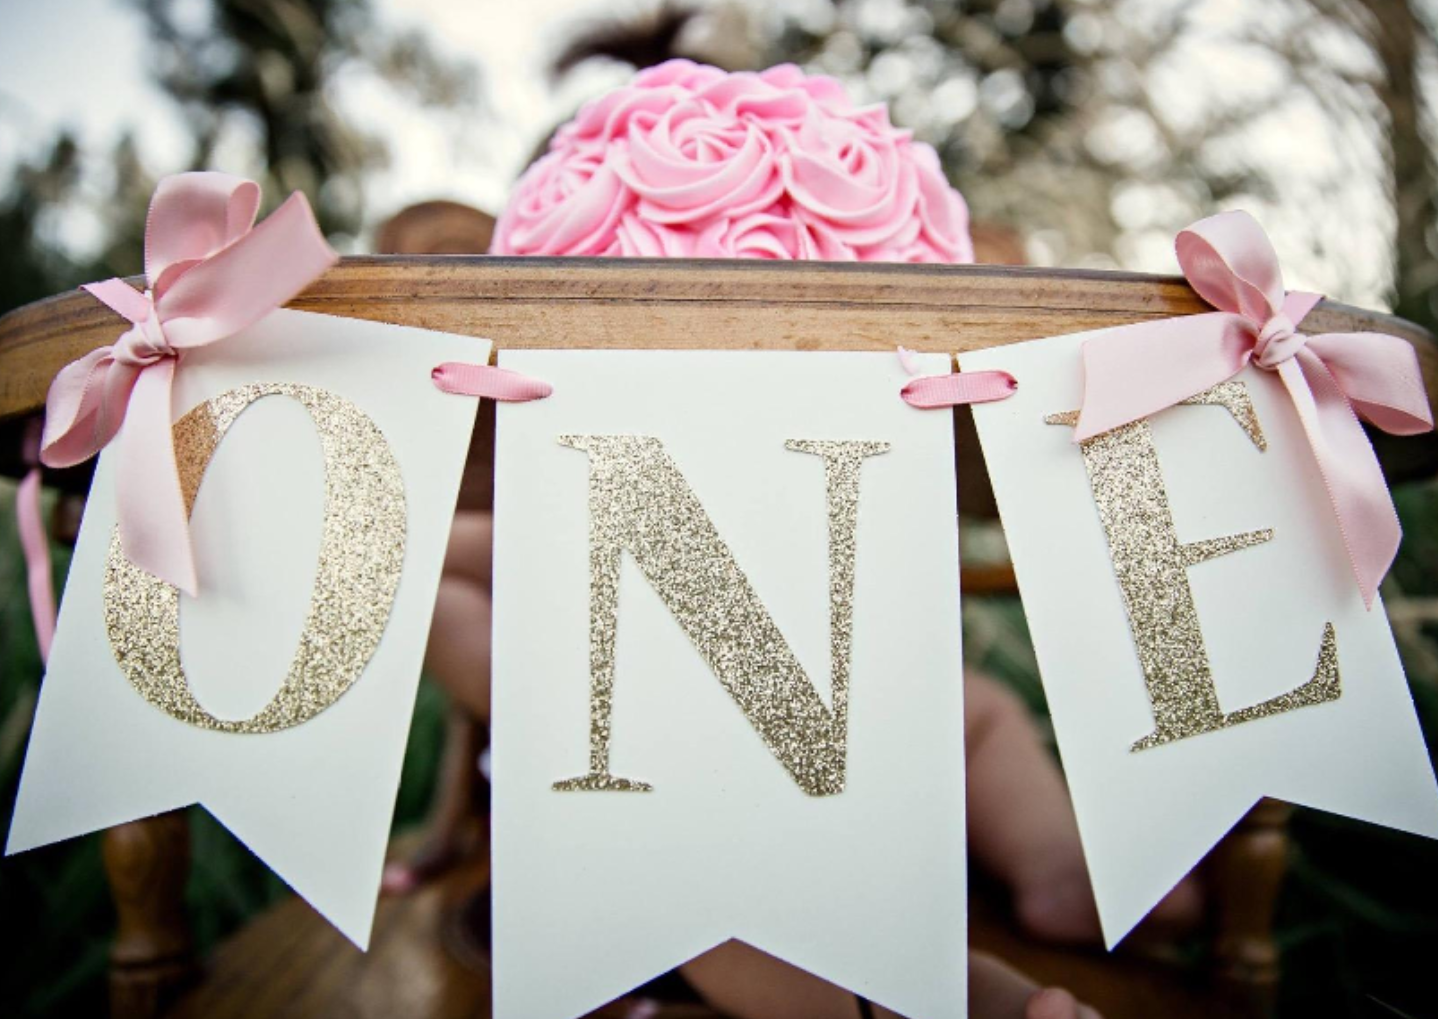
left=1044, top=381, right=1340, bottom=750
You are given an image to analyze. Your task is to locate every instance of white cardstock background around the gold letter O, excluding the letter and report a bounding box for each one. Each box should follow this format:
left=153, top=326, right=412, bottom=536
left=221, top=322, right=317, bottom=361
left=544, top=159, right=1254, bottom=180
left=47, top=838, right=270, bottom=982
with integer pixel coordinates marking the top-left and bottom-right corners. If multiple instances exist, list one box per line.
left=6, top=310, right=490, bottom=947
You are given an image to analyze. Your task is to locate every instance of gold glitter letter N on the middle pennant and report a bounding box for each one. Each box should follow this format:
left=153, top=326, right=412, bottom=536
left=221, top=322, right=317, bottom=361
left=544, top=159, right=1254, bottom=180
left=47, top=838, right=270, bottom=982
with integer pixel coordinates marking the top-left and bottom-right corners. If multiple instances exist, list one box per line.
left=554, top=435, right=889, bottom=796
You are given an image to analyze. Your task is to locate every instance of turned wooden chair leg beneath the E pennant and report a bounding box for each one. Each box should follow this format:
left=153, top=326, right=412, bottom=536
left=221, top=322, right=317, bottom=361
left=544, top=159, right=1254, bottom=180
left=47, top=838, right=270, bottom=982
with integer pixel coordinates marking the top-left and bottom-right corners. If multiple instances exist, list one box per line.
left=1208, top=799, right=1293, bottom=1019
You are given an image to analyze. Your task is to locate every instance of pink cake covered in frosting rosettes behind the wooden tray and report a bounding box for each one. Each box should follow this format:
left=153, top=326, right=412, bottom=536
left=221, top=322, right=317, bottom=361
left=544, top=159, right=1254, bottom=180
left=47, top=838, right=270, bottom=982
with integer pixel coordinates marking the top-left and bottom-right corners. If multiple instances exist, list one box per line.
left=490, top=60, right=974, bottom=262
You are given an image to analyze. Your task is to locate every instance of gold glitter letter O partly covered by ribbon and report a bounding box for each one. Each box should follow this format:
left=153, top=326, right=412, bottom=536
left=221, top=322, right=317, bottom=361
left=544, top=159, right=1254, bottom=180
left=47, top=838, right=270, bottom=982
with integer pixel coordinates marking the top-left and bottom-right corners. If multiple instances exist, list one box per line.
left=105, top=382, right=406, bottom=733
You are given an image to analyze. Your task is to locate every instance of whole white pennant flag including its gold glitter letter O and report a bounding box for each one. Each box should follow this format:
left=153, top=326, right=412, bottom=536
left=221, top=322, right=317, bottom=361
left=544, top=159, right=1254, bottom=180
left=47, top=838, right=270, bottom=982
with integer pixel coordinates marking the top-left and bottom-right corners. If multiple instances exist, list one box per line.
left=6, top=310, right=489, bottom=947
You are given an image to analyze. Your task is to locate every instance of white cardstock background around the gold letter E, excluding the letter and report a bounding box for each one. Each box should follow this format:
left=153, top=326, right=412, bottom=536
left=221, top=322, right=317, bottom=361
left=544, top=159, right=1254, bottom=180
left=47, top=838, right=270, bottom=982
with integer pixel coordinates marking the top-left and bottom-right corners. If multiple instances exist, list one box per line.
left=961, top=332, right=1438, bottom=947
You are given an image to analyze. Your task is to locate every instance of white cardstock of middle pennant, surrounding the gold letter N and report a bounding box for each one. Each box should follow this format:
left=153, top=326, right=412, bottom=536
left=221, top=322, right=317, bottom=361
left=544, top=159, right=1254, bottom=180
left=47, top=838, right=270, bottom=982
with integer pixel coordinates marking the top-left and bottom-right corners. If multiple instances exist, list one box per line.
left=493, top=351, right=966, bottom=1019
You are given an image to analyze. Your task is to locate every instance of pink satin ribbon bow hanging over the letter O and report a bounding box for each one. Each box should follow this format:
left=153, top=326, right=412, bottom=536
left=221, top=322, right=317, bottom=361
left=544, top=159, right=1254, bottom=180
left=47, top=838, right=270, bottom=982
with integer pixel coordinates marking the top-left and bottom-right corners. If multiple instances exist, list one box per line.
left=40, top=172, right=339, bottom=595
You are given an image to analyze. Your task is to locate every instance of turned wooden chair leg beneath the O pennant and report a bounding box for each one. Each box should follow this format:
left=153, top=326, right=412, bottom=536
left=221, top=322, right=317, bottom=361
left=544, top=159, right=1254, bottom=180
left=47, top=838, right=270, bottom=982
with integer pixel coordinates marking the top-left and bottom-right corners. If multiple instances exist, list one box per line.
left=104, top=811, right=196, bottom=1019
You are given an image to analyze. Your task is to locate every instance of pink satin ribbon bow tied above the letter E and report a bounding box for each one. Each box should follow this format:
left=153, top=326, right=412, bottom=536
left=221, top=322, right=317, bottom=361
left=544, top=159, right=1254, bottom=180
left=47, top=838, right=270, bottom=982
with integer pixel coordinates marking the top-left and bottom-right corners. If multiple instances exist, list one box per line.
left=1074, top=206, right=1434, bottom=608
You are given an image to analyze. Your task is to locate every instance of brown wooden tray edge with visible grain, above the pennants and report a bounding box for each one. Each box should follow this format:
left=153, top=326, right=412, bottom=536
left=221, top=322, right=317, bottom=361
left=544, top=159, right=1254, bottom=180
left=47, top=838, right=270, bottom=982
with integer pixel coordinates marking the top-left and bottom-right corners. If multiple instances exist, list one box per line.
left=0, top=256, right=1438, bottom=418
